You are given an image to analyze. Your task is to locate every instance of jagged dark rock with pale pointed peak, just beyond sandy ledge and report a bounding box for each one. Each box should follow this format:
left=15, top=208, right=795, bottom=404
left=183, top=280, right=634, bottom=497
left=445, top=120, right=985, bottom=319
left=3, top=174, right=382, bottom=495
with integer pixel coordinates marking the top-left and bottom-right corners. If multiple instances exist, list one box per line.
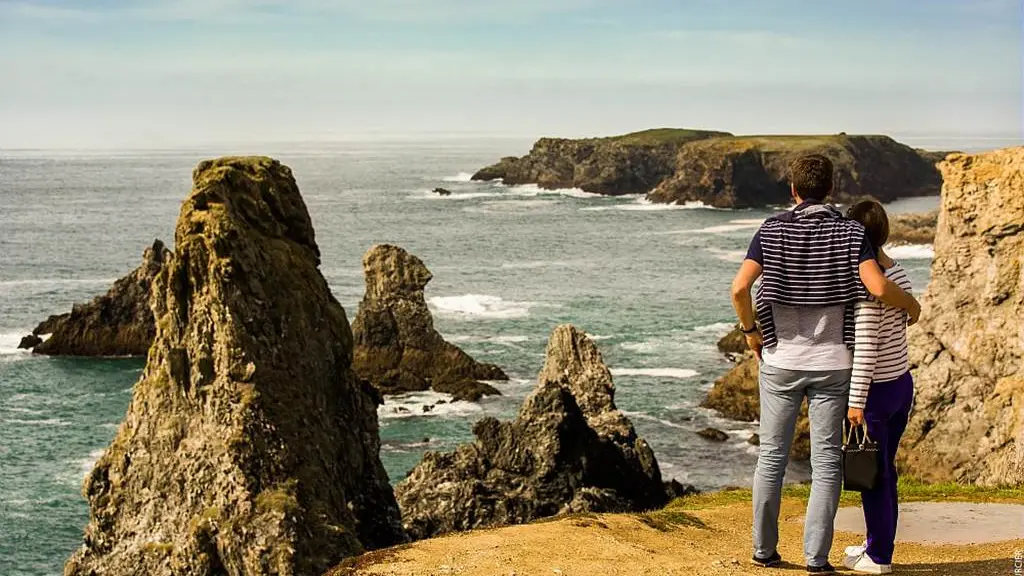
left=395, top=326, right=668, bottom=538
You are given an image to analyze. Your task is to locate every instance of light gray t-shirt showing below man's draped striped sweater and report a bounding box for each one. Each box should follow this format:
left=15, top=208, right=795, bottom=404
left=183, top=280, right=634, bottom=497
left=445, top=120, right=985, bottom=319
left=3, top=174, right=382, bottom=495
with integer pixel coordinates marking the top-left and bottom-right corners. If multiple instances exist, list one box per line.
left=762, top=304, right=853, bottom=371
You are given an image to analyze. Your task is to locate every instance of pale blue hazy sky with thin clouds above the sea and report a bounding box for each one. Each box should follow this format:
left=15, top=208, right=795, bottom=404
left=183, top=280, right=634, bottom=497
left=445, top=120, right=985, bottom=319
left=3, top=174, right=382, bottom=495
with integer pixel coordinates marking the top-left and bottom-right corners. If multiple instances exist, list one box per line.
left=0, top=0, right=1024, bottom=149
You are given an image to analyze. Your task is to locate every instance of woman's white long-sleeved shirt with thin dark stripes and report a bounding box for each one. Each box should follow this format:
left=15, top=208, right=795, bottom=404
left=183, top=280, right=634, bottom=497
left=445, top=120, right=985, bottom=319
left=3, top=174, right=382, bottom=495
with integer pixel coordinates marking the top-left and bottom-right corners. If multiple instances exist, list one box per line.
left=850, top=262, right=910, bottom=408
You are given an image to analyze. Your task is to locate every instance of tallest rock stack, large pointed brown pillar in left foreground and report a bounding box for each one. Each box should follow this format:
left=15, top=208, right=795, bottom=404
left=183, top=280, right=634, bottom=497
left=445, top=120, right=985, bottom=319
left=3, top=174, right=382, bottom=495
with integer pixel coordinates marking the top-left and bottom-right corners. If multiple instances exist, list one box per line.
left=65, top=157, right=404, bottom=576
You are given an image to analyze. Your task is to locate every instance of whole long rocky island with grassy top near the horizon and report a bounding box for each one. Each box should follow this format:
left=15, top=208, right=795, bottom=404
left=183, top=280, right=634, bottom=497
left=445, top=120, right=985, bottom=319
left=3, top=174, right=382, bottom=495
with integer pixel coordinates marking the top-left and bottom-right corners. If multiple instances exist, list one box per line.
left=473, top=128, right=942, bottom=208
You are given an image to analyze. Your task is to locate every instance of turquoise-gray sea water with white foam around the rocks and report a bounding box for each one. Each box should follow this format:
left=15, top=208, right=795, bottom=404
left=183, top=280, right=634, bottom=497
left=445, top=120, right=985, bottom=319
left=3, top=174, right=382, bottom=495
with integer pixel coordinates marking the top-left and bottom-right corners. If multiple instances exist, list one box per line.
left=0, top=140, right=937, bottom=576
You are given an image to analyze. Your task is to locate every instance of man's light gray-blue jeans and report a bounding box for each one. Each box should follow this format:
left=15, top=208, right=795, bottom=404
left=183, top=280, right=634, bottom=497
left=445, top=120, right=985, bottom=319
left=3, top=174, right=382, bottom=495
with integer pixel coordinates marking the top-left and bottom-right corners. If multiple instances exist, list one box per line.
left=754, top=363, right=850, bottom=566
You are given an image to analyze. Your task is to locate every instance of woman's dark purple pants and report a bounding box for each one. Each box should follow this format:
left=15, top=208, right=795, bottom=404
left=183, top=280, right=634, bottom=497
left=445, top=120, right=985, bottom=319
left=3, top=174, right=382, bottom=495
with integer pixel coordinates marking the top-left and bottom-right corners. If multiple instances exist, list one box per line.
left=861, top=372, right=913, bottom=564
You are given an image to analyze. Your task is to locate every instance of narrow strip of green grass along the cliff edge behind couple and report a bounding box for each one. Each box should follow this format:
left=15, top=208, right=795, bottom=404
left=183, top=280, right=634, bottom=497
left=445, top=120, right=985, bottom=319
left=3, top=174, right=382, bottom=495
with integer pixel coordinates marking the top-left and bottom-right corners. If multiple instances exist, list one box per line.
left=662, top=478, right=1024, bottom=511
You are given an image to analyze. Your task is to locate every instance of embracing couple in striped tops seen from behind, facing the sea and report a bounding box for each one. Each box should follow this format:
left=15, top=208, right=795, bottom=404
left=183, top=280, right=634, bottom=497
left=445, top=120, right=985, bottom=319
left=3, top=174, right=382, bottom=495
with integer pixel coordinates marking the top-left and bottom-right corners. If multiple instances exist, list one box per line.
left=732, top=155, right=921, bottom=574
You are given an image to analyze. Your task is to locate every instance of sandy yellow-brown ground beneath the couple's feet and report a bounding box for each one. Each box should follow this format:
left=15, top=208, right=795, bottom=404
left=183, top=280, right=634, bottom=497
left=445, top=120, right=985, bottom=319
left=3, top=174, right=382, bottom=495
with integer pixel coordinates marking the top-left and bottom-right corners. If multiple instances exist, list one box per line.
left=332, top=498, right=1024, bottom=576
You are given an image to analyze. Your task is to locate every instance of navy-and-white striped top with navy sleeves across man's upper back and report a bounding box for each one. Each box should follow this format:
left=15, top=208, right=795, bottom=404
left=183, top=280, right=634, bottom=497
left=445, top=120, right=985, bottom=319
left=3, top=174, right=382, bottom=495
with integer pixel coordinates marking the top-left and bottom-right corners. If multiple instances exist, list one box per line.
left=746, top=202, right=876, bottom=347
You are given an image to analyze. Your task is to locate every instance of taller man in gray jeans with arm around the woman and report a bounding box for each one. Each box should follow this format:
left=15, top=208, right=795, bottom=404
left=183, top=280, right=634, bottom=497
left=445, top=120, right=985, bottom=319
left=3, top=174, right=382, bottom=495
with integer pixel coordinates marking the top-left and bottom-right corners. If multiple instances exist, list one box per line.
left=732, top=155, right=921, bottom=574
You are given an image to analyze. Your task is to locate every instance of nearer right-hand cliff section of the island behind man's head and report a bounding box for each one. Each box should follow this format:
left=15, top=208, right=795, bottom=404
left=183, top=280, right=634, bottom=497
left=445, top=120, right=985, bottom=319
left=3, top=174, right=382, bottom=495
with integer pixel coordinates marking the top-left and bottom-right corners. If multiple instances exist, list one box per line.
left=647, top=134, right=942, bottom=208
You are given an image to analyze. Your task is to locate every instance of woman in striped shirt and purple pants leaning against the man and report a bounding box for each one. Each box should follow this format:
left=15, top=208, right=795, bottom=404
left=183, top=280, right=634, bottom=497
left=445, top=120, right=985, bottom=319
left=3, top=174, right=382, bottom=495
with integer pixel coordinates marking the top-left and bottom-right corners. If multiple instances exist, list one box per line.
left=843, top=201, right=913, bottom=574
